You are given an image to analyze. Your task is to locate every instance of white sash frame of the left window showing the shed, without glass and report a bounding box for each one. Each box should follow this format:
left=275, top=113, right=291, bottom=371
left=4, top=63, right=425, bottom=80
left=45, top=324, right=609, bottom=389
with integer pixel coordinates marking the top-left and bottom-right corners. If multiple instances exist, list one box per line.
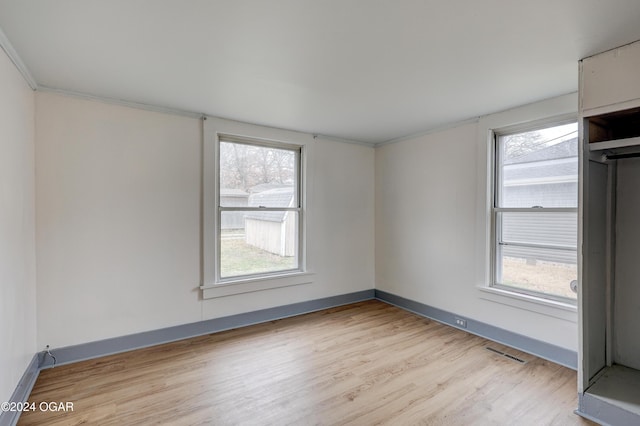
left=214, top=133, right=305, bottom=285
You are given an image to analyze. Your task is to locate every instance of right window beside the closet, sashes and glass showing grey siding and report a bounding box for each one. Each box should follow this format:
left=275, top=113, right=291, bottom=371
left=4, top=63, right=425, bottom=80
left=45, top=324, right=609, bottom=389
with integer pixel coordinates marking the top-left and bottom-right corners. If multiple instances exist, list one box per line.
left=492, top=122, right=578, bottom=303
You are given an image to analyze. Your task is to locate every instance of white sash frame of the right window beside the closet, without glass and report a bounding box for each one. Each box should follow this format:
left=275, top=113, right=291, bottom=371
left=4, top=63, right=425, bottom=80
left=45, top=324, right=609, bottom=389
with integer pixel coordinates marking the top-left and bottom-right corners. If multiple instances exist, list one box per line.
left=488, top=120, right=580, bottom=306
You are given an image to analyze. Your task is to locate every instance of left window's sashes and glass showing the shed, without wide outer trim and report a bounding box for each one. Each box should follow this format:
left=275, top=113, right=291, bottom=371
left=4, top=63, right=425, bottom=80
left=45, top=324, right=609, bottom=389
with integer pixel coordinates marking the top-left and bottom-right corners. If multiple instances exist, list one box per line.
left=216, top=135, right=304, bottom=282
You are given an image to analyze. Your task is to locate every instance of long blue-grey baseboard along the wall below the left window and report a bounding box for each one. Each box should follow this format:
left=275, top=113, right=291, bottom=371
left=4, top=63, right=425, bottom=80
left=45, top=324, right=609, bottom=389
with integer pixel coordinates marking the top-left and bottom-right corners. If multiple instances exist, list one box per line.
left=40, top=289, right=375, bottom=369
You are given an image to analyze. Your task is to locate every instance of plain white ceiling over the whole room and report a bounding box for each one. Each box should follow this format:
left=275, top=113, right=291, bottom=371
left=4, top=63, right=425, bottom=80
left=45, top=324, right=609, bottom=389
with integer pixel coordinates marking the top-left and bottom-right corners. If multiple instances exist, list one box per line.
left=0, top=0, right=640, bottom=143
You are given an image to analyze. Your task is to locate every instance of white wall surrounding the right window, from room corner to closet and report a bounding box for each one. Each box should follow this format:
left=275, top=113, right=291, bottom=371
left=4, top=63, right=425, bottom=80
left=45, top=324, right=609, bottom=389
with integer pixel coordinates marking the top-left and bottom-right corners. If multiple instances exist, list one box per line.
left=375, top=95, right=577, bottom=350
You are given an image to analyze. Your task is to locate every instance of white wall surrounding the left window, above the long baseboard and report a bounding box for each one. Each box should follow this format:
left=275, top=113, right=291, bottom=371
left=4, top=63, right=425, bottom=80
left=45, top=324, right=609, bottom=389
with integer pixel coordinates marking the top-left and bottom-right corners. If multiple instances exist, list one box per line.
left=36, top=92, right=374, bottom=348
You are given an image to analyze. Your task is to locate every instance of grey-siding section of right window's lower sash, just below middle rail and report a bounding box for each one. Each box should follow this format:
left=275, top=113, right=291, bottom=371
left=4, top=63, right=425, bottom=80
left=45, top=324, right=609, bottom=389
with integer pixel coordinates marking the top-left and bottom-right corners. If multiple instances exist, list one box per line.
left=497, top=211, right=578, bottom=251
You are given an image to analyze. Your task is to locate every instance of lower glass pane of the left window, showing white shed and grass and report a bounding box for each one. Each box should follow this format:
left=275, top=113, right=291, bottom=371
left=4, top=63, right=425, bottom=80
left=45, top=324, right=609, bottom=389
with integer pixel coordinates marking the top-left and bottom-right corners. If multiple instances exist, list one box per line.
left=220, top=210, right=299, bottom=278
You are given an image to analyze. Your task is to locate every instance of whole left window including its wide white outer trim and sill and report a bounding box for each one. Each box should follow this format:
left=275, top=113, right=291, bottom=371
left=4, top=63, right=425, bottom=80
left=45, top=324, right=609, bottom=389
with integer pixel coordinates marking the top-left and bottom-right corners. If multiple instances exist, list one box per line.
left=200, top=117, right=315, bottom=299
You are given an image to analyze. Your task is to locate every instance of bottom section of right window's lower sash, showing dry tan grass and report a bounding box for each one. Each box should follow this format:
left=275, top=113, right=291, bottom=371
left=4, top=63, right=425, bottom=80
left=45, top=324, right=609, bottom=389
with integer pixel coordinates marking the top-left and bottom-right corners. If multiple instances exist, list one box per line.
left=498, top=248, right=578, bottom=299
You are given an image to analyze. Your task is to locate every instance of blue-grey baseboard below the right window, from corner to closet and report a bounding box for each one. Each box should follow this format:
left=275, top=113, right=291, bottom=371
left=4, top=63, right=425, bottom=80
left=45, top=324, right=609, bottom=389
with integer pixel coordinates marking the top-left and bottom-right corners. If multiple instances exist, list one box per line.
left=375, top=290, right=578, bottom=370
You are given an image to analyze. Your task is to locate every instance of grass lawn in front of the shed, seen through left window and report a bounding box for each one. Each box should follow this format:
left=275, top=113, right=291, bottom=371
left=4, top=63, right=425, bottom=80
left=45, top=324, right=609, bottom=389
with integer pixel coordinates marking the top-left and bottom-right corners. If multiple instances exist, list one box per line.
left=220, top=234, right=296, bottom=278
